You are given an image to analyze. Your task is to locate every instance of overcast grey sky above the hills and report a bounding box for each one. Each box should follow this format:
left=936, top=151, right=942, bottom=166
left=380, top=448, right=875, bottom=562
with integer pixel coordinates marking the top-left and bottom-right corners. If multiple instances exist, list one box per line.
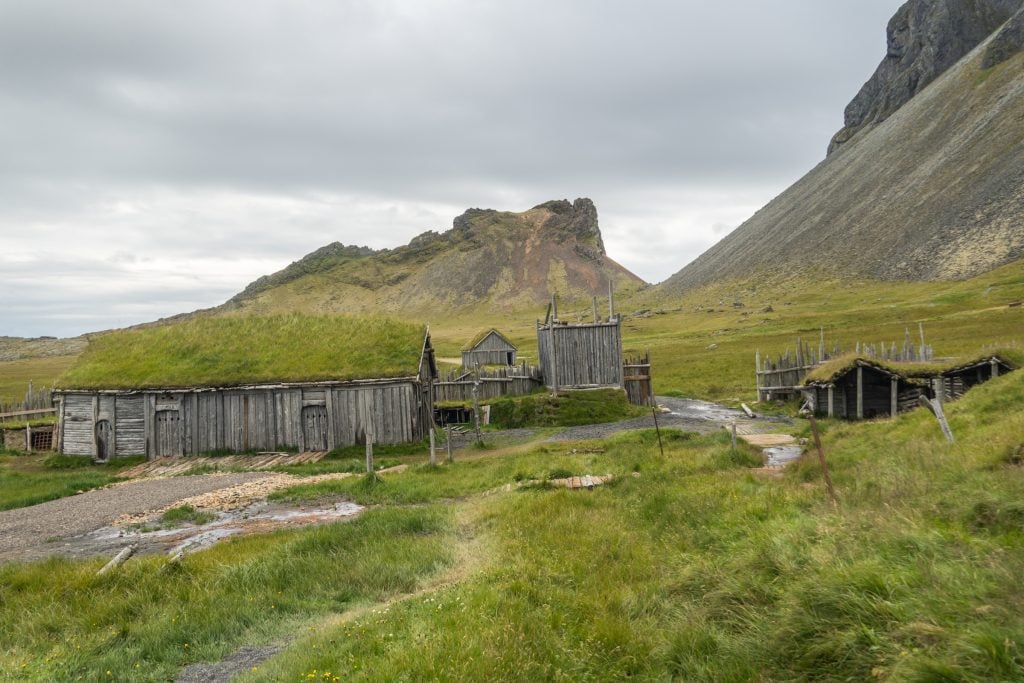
left=0, top=0, right=900, bottom=336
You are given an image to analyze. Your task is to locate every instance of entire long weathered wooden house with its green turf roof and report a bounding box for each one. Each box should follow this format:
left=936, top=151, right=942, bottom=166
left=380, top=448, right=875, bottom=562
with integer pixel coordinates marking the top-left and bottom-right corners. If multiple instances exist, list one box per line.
left=55, top=315, right=437, bottom=460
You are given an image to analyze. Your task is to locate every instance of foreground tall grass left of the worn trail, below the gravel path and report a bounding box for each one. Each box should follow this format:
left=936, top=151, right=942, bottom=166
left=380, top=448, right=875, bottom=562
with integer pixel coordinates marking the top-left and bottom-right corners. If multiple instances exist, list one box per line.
left=0, top=508, right=453, bottom=681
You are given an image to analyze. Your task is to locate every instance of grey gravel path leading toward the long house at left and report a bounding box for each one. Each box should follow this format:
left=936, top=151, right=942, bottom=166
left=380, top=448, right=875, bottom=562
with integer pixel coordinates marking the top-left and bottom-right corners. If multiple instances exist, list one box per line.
left=0, top=472, right=272, bottom=561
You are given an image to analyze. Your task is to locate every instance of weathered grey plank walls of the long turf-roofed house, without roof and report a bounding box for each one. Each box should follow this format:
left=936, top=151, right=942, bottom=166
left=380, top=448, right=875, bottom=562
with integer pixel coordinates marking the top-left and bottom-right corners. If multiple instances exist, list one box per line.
left=55, top=319, right=437, bottom=461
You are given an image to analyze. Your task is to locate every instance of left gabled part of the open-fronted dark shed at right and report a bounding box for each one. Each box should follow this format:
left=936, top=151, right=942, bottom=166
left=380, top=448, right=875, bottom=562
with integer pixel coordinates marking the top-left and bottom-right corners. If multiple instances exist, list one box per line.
left=801, top=358, right=928, bottom=420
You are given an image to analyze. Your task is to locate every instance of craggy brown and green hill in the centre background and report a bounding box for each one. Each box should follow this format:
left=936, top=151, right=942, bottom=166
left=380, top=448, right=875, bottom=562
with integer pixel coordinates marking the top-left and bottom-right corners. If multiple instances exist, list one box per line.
left=220, top=199, right=643, bottom=313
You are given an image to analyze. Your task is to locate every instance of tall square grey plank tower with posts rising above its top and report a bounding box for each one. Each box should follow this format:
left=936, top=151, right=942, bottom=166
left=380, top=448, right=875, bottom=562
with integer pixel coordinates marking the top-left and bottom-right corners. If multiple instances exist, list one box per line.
left=537, top=316, right=623, bottom=390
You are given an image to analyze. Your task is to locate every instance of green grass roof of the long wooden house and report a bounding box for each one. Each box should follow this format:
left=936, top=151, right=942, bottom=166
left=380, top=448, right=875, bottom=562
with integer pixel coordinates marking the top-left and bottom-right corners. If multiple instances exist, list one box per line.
left=57, top=314, right=426, bottom=389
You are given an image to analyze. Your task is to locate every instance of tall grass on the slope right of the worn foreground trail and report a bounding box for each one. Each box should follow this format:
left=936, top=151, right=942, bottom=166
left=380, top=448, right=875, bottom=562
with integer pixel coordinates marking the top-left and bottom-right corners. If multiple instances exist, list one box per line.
left=247, top=376, right=1024, bottom=681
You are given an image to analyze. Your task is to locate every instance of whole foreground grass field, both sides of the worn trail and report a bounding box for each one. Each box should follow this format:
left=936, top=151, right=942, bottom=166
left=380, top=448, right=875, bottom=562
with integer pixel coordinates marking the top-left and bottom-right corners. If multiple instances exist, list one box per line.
left=0, top=373, right=1024, bottom=681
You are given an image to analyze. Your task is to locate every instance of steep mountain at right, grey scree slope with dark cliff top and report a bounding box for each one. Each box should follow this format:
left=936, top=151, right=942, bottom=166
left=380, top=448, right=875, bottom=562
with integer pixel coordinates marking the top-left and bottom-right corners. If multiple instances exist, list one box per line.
left=662, top=0, right=1024, bottom=292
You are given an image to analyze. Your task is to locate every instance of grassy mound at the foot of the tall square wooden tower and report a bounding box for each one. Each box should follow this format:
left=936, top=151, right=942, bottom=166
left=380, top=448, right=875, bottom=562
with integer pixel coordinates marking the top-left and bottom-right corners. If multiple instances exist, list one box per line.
left=490, top=389, right=647, bottom=429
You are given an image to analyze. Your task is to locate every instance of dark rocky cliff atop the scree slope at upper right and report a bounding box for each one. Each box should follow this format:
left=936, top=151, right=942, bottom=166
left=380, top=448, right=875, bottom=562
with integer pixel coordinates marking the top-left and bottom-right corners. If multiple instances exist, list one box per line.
left=828, top=0, right=1024, bottom=154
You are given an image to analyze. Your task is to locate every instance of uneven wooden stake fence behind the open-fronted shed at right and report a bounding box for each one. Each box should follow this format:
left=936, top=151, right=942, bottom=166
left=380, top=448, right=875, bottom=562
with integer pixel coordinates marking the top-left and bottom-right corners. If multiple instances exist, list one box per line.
left=755, top=328, right=935, bottom=400
